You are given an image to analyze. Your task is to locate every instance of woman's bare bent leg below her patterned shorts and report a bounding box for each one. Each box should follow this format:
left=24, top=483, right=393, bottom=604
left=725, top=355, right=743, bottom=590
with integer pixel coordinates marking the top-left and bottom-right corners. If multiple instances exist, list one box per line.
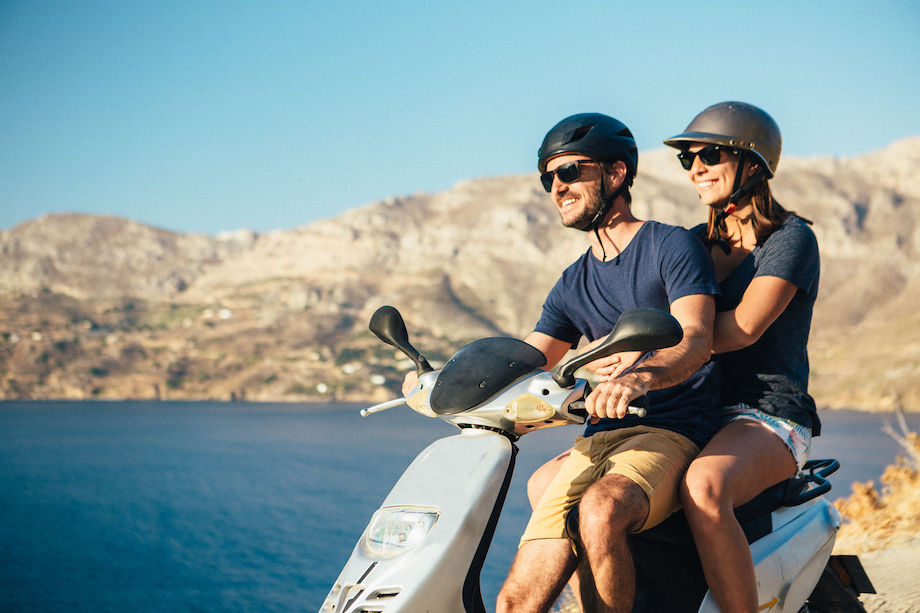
left=681, top=419, right=797, bottom=613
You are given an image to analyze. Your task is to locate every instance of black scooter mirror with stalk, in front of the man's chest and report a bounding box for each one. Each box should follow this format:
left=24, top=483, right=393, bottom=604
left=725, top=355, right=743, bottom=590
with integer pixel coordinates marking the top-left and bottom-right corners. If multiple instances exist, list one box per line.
left=553, top=309, right=684, bottom=387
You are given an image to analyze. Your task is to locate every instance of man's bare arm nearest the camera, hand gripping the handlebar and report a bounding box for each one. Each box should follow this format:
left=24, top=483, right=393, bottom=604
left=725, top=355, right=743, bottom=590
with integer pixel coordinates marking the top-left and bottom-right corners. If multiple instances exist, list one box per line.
left=586, top=294, right=715, bottom=418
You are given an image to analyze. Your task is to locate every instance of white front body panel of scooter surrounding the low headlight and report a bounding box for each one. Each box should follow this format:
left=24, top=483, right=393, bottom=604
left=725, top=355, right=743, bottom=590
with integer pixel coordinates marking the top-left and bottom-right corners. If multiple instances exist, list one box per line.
left=321, top=429, right=516, bottom=613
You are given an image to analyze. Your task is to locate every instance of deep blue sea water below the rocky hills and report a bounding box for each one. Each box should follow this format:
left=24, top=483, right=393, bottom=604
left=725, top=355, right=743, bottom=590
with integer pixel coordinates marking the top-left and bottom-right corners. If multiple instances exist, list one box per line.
left=0, top=402, right=920, bottom=612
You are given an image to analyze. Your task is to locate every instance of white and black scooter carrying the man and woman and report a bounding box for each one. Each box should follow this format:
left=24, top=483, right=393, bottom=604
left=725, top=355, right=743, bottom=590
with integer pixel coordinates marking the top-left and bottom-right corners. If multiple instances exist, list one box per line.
left=320, top=306, right=874, bottom=613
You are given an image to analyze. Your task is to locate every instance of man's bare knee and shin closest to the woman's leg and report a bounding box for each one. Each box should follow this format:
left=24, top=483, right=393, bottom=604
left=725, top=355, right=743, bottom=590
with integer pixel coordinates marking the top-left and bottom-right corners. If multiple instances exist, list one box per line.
left=578, top=474, right=649, bottom=613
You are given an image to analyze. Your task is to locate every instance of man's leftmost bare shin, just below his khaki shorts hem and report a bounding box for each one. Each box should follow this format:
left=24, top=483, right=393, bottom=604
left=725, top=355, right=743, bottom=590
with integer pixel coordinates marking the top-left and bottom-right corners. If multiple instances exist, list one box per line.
left=496, top=538, right=575, bottom=613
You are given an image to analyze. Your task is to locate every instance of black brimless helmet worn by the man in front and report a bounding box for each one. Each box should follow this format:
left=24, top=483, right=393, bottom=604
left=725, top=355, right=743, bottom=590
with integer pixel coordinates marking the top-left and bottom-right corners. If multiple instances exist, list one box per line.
left=537, top=113, right=639, bottom=177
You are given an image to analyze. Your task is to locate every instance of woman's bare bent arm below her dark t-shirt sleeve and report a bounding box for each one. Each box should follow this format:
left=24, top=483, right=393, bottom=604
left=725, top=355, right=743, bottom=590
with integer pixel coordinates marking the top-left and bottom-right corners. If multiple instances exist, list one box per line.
left=712, top=276, right=799, bottom=353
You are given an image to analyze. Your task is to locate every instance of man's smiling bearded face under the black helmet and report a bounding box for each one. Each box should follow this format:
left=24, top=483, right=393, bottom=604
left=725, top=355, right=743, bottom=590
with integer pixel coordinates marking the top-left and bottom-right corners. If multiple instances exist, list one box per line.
left=546, top=153, right=603, bottom=230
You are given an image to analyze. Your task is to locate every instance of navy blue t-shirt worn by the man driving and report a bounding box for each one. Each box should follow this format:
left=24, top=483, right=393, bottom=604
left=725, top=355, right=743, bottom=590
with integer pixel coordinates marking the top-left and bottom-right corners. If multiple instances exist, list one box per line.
left=536, top=221, right=721, bottom=448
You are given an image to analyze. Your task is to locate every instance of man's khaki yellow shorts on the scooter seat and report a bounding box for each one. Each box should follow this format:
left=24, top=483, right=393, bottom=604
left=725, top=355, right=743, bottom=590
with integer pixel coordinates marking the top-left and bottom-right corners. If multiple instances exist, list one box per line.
left=521, top=426, right=700, bottom=545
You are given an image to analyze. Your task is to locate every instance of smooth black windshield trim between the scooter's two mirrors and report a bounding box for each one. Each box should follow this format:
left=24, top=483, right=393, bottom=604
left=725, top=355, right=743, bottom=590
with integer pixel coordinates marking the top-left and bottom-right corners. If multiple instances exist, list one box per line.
left=429, top=337, right=546, bottom=415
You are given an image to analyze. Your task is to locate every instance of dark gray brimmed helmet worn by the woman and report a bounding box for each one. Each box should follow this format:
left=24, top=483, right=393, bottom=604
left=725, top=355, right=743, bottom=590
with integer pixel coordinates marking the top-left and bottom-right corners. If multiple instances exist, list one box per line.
left=664, top=102, right=783, bottom=177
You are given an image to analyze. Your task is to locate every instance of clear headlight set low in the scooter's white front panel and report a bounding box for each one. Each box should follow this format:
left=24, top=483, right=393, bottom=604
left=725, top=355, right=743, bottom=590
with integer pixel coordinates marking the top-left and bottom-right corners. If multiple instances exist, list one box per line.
left=363, top=507, right=440, bottom=558
